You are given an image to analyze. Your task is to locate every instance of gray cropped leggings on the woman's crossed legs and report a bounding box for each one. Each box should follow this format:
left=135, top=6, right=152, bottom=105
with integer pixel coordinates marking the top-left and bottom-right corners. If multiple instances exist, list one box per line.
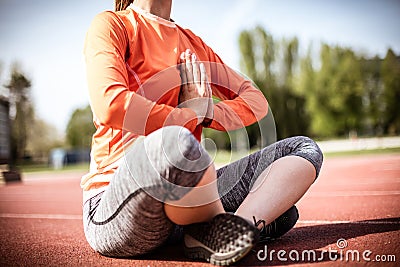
left=83, top=126, right=323, bottom=257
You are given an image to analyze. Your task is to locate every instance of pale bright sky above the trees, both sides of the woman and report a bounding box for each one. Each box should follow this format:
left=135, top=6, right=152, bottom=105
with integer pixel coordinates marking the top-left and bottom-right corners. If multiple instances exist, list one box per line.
left=0, top=0, right=400, bottom=132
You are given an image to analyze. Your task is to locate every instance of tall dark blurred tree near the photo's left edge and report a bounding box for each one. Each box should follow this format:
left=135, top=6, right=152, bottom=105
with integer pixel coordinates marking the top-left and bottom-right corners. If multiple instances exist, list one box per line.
left=5, top=63, right=34, bottom=163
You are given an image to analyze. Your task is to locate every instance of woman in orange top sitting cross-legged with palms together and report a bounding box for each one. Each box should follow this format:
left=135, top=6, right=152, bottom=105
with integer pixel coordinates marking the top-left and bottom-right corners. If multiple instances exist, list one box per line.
left=81, top=0, right=322, bottom=265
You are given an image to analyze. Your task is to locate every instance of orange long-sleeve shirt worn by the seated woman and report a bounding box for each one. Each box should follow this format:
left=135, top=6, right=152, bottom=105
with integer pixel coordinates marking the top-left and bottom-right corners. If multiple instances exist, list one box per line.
left=81, top=5, right=268, bottom=199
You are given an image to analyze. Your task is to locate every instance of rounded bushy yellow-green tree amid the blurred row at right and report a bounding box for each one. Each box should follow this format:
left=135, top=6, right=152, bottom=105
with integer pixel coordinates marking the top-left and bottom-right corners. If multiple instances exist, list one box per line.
left=306, top=44, right=364, bottom=137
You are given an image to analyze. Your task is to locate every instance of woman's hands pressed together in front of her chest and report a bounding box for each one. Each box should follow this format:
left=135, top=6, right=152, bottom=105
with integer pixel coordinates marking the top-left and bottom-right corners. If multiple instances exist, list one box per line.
left=179, top=49, right=214, bottom=126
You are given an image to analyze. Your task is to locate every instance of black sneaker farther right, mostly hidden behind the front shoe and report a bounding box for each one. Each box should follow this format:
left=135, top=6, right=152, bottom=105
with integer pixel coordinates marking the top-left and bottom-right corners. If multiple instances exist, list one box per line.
left=253, top=206, right=299, bottom=242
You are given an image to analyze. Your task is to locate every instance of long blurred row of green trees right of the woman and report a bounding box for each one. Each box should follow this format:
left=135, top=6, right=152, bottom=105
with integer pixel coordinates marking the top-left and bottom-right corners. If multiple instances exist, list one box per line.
left=206, top=26, right=400, bottom=149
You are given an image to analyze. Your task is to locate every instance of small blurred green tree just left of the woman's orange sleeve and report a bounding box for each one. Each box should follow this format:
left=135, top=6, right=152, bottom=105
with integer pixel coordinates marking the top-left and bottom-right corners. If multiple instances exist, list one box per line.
left=67, top=106, right=95, bottom=148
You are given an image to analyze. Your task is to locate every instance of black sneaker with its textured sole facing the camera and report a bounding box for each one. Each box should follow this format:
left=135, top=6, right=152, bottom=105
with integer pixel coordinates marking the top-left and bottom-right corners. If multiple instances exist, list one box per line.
left=184, top=213, right=260, bottom=265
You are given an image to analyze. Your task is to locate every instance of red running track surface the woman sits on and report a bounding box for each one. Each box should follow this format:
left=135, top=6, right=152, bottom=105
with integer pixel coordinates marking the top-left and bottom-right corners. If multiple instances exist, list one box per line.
left=0, top=154, right=400, bottom=266
